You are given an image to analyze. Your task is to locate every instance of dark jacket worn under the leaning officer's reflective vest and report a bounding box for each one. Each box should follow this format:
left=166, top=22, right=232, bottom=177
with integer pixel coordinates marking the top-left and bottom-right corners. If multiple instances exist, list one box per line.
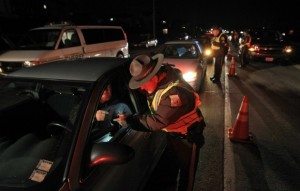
left=129, top=68, right=202, bottom=137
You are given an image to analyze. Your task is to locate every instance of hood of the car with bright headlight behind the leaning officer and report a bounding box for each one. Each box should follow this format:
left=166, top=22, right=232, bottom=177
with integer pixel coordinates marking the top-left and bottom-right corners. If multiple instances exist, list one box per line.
left=163, top=58, right=199, bottom=73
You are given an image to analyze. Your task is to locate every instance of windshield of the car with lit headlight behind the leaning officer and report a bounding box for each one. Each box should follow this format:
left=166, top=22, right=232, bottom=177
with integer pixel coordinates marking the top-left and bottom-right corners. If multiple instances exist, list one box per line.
left=159, top=44, right=199, bottom=59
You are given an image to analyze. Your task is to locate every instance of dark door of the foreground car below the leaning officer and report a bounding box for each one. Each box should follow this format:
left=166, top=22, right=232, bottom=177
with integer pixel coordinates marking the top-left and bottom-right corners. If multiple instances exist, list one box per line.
left=81, top=66, right=166, bottom=191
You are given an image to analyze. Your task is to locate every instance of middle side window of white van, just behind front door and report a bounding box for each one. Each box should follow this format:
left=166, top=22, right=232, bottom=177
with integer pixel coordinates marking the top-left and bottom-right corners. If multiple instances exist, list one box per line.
left=82, top=29, right=106, bottom=45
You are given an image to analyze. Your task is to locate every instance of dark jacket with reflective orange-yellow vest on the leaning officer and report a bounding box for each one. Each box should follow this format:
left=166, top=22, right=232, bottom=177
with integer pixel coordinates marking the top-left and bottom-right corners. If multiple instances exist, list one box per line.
left=126, top=67, right=204, bottom=135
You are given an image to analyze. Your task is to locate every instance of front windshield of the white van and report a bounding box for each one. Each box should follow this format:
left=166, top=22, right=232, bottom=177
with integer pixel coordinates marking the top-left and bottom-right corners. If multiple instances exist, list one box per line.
left=17, top=29, right=61, bottom=50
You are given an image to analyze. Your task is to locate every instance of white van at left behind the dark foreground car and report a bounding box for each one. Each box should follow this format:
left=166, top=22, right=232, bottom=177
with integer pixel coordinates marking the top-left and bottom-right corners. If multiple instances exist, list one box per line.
left=0, top=25, right=129, bottom=74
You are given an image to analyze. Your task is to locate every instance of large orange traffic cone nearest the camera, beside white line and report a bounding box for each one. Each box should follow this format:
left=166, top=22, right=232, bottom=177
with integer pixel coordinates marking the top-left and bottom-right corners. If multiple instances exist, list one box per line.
left=228, top=96, right=252, bottom=143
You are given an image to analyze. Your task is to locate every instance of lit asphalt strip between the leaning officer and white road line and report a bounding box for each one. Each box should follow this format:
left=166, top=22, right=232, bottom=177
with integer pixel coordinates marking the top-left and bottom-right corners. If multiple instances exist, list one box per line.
left=194, top=63, right=224, bottom=191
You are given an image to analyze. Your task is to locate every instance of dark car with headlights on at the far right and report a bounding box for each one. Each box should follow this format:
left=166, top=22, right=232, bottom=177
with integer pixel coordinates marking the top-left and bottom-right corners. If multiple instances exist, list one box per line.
left=241, top=29, right=293, bottom=65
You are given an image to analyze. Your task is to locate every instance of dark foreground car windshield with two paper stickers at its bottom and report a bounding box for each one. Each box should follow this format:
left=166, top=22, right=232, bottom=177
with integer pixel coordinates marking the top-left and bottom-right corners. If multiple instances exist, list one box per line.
left=0, top=80, right=88, bottom=190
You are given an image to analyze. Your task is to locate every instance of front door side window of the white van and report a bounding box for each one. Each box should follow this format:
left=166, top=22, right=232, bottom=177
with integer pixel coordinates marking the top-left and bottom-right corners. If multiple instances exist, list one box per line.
left=59, top=30, right=80, bottom=48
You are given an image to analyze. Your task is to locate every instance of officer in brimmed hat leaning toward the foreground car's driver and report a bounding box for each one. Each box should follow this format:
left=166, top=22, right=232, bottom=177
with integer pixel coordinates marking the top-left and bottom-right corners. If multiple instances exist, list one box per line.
left=113, top=54, right=205, bottom=191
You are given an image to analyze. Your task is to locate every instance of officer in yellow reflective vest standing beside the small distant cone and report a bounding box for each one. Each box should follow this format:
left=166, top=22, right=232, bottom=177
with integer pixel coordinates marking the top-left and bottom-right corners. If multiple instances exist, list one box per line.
left=210, top=26, right=228, bottom=83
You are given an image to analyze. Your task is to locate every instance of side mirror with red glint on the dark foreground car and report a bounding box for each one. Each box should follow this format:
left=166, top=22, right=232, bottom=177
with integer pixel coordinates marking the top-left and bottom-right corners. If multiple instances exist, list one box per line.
left=89, top=142, right=134, bottom=167
